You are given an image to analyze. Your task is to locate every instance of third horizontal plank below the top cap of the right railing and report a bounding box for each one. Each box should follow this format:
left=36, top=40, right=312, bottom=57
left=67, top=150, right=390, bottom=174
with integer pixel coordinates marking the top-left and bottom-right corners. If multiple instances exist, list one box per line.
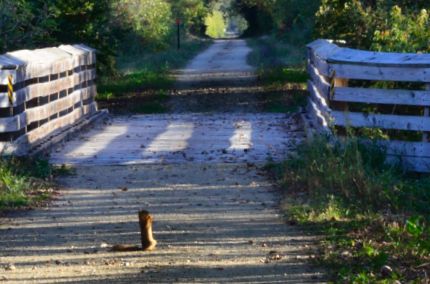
left=331, top=111, right=430, bottom=131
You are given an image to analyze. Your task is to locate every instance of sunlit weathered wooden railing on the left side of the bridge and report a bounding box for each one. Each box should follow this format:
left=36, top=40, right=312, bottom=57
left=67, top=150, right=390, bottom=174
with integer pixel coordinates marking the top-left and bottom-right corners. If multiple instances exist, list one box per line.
left=0, top=45, right=97, bottom=155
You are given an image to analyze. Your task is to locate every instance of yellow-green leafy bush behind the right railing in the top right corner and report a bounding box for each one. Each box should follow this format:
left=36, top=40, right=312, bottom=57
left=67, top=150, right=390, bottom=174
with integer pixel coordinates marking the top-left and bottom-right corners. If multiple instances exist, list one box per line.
left=316, top=0, right=430, bottom=52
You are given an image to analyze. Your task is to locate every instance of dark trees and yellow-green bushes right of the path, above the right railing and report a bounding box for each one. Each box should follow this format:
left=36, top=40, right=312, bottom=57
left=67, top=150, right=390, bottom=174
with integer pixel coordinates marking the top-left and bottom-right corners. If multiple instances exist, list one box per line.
left=236, top=0, right=430, bottom=52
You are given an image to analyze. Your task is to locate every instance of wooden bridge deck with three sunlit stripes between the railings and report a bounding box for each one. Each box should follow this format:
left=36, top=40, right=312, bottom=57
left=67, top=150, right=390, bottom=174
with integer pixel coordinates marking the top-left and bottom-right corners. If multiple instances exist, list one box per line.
left=51, top=113, right=302, bottom=165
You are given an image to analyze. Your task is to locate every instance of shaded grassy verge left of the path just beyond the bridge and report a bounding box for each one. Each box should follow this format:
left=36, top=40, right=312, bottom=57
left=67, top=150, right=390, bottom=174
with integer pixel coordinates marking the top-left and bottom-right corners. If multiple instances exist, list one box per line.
left=97, top=38, right=210, bottom=113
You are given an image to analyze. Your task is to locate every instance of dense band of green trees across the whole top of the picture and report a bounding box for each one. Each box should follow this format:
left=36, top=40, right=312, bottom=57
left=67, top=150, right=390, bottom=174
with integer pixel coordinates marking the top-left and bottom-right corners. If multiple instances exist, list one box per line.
left=0, top=0, right=430, bottom=73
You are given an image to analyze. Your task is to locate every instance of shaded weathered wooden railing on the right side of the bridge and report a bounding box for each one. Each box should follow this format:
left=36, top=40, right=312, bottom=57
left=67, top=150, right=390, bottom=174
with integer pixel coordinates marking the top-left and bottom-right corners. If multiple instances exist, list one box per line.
left=307, top=40, right=430, bottom=172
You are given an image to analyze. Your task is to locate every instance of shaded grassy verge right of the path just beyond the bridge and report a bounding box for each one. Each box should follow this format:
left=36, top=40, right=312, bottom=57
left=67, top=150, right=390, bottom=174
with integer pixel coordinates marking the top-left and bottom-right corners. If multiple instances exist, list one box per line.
left=248, top=36, right=308, bottom=113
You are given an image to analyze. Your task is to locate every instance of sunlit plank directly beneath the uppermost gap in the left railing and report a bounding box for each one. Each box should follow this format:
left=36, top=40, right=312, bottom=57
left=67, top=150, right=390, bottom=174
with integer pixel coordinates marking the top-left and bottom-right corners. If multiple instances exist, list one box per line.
left=0, top=69, right=96, bottom=108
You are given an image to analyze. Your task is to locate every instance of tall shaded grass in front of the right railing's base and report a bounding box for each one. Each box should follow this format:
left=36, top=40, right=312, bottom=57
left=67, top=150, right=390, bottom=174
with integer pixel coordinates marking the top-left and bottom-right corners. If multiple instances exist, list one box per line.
left=283, top=137, right=430, bottom=215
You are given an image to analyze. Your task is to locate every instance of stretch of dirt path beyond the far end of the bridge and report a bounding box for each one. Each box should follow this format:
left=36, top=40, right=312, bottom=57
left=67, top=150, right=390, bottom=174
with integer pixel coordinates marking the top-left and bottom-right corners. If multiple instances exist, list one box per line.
left=169, top=40, right=259, bottom=113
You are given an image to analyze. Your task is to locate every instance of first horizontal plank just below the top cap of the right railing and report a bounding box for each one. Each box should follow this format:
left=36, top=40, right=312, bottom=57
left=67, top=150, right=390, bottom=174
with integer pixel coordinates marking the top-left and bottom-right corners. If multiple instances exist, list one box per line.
left=330, top=63, right=430, bottom=83
